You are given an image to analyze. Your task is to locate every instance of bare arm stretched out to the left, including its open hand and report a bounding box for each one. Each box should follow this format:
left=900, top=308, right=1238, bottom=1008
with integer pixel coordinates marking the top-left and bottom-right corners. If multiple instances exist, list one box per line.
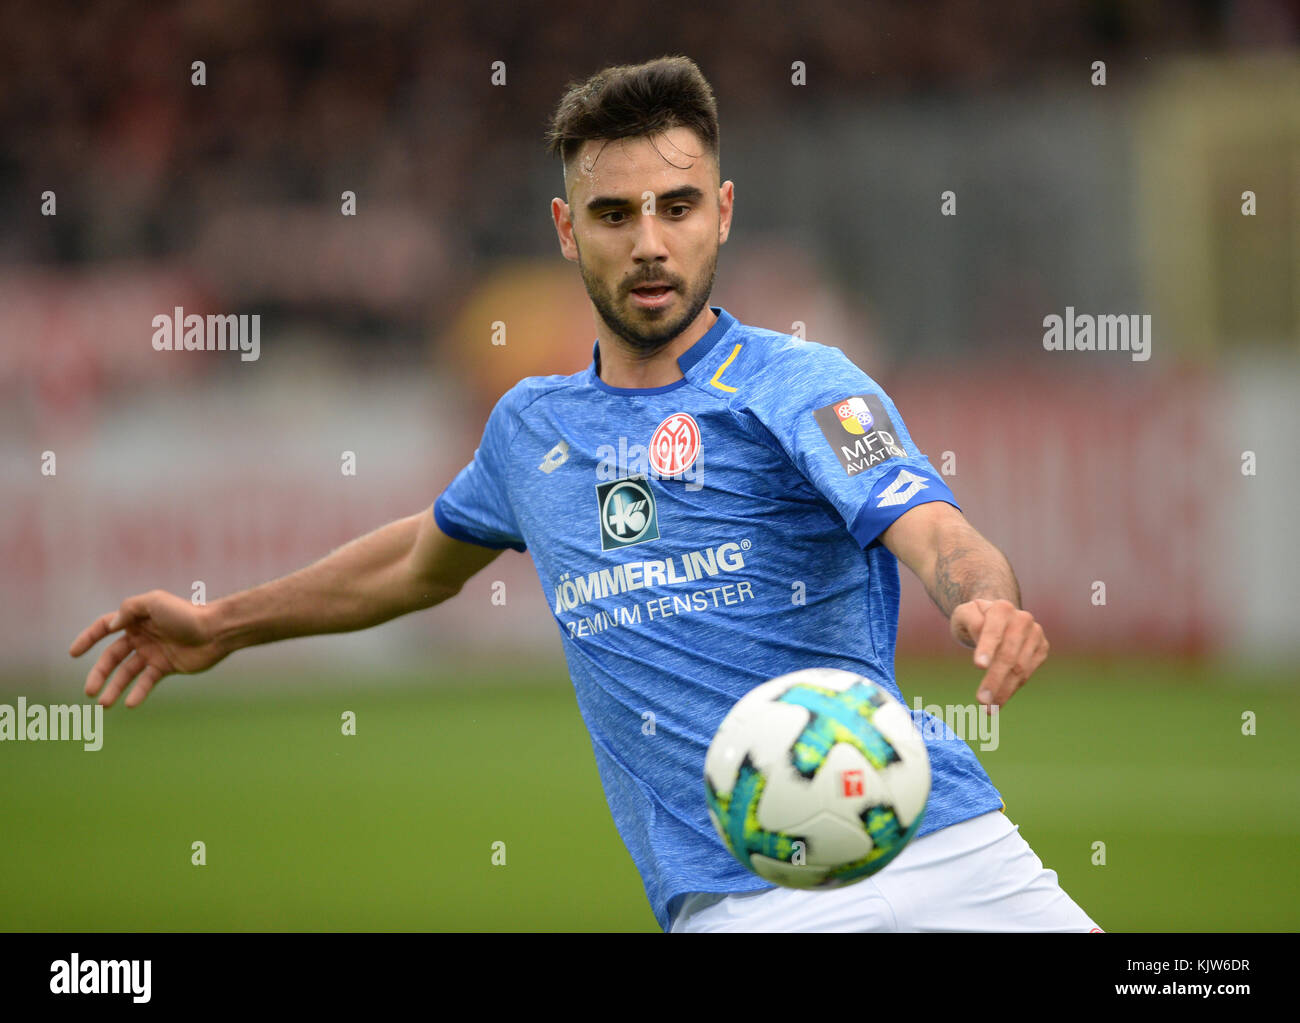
left=68, top=510, right=501, bottom=707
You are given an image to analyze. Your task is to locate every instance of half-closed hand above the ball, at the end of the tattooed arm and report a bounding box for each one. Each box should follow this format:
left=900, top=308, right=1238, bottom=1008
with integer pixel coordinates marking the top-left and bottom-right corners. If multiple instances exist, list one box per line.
left=949, top=598, right=1049, bottom=707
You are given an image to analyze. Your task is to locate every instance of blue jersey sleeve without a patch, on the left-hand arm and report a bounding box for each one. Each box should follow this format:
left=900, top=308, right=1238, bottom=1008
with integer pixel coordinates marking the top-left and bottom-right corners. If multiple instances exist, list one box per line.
left=433, top=391, right=527, bottom=551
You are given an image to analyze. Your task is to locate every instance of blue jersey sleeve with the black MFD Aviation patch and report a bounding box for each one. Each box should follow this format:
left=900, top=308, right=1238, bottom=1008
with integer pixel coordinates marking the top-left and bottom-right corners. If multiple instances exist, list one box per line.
left=754, top=342, right=961, bottom=549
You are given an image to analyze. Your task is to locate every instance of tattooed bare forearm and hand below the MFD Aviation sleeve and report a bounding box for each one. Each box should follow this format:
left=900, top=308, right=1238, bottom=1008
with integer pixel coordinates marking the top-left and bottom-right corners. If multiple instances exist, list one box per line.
left=880, top=500, right=1048, bottom=707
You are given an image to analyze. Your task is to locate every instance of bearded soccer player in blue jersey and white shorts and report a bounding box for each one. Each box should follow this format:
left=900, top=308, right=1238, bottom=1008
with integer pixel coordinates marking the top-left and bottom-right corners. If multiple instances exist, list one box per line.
left=70, top=57, right=1096, bottom=931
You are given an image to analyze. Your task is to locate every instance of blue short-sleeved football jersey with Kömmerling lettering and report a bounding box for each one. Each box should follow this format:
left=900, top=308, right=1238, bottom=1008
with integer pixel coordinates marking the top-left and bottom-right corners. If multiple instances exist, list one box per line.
left=433, top=307, right=1002, bottom=929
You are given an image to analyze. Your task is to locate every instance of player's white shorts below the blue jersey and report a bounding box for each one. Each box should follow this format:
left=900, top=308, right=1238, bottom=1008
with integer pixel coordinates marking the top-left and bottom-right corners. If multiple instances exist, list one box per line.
left=672, top=811, right=1101, bottom=933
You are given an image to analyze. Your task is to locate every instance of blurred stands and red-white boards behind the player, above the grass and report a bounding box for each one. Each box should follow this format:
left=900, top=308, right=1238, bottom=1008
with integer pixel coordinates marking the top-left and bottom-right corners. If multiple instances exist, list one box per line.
left=0, top=0, right=1300, bottom=669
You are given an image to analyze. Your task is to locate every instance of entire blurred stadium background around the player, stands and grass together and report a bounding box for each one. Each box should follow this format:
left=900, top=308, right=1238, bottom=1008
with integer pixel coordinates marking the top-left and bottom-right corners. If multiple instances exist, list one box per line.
left=0, top=0, right=1300, bottom=931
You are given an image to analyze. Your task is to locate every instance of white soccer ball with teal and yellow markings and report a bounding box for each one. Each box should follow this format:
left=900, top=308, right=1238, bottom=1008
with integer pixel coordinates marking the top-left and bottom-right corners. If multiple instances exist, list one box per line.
left=705, top=668, right=930, bottom=888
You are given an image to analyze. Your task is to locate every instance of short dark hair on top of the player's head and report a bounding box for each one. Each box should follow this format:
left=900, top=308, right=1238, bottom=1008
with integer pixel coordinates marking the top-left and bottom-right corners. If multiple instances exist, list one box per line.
left=546, top=57, right=718, bottom=179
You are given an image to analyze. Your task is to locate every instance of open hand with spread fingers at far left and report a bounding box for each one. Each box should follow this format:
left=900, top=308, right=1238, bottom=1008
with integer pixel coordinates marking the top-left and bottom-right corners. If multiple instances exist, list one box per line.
left=68, top=590, right=228, bottom=707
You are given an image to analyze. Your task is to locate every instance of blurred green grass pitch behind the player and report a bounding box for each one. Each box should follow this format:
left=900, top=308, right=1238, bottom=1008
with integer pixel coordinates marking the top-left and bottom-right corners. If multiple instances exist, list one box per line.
left=0, top=655, right=1300, bottom=931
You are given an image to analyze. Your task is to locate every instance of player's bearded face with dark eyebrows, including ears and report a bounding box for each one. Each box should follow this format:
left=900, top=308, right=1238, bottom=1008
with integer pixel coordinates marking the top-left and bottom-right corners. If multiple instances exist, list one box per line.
left=551, top=127, right=733, bottom=355
